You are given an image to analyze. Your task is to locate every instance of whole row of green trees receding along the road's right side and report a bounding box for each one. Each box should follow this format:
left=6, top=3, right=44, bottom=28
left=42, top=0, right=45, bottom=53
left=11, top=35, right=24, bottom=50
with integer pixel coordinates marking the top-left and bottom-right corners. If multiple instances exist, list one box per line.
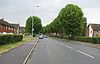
left=41, top=4, right=86, bottom=36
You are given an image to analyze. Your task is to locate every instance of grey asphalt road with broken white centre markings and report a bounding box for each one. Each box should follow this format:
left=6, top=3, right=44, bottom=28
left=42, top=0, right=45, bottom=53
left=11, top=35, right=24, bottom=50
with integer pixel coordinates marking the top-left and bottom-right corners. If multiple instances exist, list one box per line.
left=27, top=38, right=100, bottom=64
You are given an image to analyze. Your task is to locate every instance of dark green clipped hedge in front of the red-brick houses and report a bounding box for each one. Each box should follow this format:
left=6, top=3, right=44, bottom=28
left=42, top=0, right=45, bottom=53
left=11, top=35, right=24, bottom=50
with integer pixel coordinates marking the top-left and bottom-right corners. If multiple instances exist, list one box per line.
left=0, top=35, right=23, bottom=45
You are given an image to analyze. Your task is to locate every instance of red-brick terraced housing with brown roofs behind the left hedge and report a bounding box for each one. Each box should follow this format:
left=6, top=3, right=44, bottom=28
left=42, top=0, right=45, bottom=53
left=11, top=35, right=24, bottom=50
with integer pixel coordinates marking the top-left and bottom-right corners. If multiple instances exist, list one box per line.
left=0, top=19, right=19, bottom=34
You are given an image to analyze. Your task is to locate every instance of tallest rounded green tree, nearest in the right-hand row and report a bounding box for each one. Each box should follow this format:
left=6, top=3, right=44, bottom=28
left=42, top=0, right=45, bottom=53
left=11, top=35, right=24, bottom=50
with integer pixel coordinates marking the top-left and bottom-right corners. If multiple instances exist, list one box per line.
left=58, top=4, right=85, bottom=36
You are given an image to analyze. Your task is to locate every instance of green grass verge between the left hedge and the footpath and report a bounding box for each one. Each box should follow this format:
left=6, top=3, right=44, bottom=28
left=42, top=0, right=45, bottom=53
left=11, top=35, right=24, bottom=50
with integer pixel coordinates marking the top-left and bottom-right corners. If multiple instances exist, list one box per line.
left=0, top=36, right=33, bottom=53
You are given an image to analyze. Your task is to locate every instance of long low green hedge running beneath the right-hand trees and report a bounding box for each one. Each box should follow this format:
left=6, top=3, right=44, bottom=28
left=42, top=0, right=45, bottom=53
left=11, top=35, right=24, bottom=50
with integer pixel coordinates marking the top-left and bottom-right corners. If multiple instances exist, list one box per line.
left=52, top=36, right=100, bottom=44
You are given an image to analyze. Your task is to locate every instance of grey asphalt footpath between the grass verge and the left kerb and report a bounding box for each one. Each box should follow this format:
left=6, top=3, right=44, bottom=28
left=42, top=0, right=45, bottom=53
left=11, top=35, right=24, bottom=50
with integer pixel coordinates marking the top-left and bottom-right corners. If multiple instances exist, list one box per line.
left=0, top=39, right=37, bottom=64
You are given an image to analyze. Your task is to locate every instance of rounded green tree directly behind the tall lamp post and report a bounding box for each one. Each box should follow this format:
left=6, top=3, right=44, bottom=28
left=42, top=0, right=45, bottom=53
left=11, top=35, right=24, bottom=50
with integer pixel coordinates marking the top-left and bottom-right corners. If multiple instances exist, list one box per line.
left=25, top=16, right=42, bottom=34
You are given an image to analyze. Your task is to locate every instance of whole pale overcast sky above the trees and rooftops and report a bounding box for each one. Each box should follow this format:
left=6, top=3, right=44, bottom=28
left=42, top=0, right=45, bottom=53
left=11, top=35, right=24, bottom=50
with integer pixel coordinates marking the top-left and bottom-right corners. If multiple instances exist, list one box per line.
left=0, top=0, right=100, bottom=26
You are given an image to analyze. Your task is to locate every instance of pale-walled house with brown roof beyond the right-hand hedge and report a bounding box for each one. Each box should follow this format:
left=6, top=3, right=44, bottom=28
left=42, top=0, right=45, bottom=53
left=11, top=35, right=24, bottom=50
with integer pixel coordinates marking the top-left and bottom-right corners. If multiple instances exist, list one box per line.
left=86, top=24, right=100, bottom=37
